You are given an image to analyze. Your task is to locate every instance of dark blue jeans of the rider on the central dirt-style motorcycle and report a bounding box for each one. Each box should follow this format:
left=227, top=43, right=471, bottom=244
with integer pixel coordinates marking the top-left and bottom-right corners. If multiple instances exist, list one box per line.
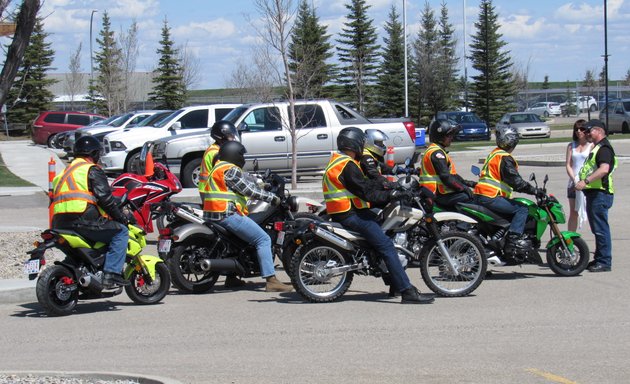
left=340, top=209, right=411, bottom=292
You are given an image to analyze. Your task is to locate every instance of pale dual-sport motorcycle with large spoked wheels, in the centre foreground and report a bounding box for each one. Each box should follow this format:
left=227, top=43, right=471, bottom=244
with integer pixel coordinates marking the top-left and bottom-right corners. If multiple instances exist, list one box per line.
left=290, top=177, right=487, bottom=303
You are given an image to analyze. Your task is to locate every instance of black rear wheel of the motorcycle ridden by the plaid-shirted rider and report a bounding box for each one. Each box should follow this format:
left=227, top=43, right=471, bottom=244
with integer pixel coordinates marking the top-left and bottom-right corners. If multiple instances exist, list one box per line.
left=168, top=238, right=221, bottom=293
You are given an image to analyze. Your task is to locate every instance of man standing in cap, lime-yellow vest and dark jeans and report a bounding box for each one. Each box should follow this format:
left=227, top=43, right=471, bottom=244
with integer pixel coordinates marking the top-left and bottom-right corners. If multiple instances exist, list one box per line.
left=575, top=120, right=617, bottom=272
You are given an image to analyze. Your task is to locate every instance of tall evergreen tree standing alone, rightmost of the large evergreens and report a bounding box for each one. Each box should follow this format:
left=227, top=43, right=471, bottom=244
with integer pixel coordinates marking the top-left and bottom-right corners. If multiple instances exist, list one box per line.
left=470, top=0, right=516, bottom=126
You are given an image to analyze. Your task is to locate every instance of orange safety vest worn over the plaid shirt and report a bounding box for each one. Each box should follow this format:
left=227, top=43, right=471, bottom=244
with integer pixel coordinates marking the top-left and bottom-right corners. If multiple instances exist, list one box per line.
left=203, top=161, right=249, bottom=216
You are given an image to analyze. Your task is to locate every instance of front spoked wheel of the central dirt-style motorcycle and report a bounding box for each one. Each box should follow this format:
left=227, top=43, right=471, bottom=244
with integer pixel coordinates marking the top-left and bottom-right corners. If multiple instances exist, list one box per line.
left=420, top=232, right=488, bottom=297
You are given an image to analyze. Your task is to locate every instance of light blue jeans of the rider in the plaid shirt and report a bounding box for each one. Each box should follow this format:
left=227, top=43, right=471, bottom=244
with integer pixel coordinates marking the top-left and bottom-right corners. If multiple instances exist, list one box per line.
left=221, top=214, right=276, bottom=277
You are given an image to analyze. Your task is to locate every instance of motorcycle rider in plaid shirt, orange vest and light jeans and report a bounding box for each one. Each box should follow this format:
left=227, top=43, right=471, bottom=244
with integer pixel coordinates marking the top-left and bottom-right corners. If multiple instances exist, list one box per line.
left=203, top=141, right=293, bottom=292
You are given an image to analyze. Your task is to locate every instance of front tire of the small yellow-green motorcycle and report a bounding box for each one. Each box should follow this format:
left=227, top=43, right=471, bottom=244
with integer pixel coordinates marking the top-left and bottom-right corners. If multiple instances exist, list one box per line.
left=125, top=263, right=171, bottom=304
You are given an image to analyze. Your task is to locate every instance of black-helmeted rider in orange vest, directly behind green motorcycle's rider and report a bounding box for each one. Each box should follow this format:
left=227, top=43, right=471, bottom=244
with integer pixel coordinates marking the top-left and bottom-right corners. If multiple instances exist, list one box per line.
left=420, top=119, right=477, bottom=209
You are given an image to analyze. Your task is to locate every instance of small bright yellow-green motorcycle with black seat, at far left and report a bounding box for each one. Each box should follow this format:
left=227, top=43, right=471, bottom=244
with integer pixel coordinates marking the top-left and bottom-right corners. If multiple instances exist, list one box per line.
left=24, top=188, right=171, bottom=316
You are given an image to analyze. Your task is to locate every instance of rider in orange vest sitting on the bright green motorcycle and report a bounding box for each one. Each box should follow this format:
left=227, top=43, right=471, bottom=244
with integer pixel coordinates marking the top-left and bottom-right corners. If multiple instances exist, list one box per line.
left=475, top=125, right=545, bottom=253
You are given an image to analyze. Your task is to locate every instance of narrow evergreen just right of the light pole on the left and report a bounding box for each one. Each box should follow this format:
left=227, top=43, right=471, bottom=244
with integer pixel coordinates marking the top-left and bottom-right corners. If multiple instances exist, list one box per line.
left=88, top=11, right=125, bottom=116
